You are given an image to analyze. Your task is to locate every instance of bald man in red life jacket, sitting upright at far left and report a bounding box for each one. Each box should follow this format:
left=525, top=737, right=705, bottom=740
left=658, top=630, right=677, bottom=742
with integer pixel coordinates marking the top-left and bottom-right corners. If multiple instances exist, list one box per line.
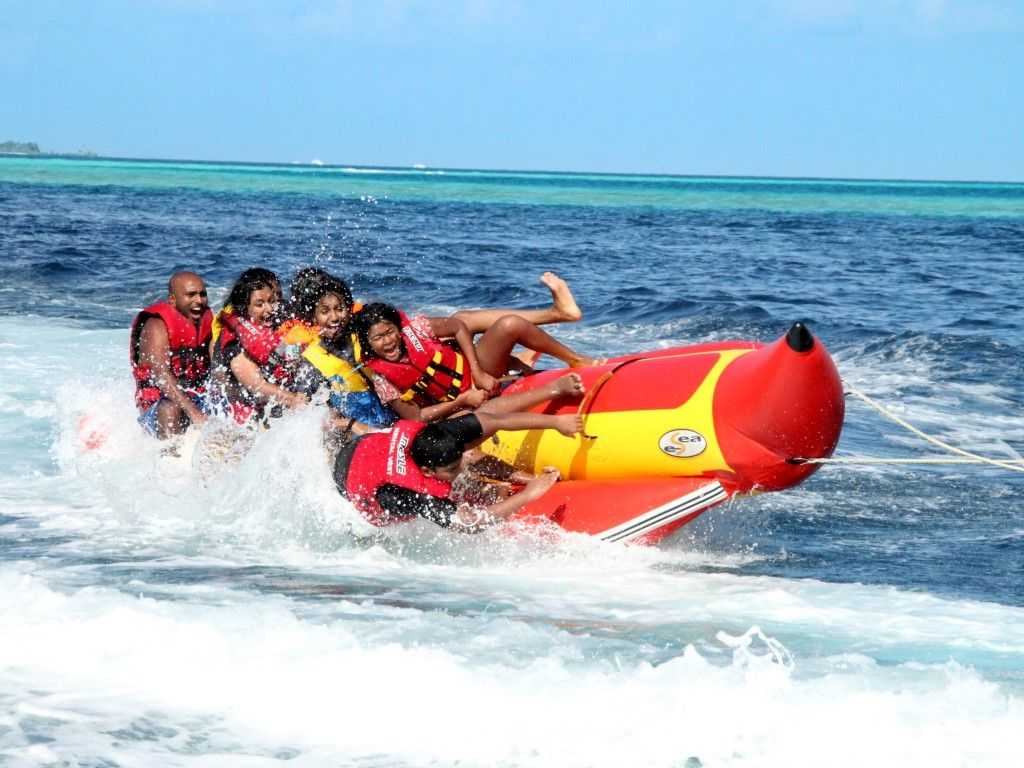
left=128, top=272, right=213, bottom=439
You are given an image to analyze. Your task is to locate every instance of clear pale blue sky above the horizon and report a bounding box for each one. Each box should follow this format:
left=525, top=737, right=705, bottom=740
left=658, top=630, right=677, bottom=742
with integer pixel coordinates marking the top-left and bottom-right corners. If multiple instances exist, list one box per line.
left=0, top=0, right=1024, bottom=180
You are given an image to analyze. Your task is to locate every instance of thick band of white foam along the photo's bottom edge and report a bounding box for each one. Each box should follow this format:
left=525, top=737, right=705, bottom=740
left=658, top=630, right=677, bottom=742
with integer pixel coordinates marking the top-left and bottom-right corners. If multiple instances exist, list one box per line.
left=0, top=567, right=1024, bottom=766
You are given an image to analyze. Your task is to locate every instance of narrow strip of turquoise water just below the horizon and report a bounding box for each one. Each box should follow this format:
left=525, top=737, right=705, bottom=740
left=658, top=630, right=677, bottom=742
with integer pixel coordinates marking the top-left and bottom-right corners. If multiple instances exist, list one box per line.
left=8, top=158, right=1024, bottom=217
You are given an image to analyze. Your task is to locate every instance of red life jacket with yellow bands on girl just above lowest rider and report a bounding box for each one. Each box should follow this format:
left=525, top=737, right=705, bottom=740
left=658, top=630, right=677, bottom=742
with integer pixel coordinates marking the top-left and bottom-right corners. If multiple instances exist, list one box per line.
left=367, top=312, right=473, bottom=406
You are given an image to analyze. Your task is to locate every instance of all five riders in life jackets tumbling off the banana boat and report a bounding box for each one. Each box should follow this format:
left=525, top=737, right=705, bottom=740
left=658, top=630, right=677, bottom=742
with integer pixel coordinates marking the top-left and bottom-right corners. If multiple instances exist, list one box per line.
left=129, top=267, right=595, bottom=532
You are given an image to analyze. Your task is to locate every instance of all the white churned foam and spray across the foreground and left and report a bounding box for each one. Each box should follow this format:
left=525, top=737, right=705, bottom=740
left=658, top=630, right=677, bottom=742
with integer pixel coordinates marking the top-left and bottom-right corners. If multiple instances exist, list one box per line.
left=0, top=319, right=1024, bottom=767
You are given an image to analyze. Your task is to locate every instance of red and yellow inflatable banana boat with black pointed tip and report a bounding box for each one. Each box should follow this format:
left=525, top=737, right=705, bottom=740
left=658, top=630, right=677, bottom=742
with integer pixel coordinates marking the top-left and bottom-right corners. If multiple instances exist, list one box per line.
left=482, top=323, right=845, bottom=544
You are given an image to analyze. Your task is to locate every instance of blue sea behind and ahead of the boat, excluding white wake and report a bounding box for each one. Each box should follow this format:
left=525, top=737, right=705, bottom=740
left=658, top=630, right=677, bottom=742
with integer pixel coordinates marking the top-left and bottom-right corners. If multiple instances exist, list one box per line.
left=0, top=161, right=1024, bottom=605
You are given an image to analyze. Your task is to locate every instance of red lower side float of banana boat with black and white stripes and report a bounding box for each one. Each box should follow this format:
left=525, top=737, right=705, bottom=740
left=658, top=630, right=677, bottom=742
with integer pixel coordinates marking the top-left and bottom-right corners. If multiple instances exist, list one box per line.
left=517, top=477, right=730, bottom=544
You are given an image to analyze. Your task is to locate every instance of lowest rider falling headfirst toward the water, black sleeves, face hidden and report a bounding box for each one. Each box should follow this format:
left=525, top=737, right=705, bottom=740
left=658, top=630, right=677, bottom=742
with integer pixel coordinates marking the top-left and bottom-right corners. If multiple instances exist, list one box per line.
left=334, top=374, right=583, bottom=532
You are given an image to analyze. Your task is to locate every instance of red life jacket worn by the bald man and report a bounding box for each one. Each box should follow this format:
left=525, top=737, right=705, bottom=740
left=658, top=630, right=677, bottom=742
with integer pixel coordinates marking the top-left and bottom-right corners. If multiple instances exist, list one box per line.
left=128, top=301, right=213, bottom=411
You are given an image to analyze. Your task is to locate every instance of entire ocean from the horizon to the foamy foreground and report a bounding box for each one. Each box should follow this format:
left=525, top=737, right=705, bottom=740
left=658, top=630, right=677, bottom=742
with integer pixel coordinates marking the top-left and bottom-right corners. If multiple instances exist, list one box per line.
left=0, top=158, right=1024, bottom=768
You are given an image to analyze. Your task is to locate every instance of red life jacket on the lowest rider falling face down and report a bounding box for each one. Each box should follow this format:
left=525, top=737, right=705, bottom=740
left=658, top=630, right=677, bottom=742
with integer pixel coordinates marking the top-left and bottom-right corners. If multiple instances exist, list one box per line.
left=345, top=419, right=452, bottom=527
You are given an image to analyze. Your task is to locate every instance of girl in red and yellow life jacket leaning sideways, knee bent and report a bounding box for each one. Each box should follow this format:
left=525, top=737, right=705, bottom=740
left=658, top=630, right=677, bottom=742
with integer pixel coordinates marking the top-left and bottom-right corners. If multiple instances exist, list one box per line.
left=354, top=296, right=595, bottom=421
